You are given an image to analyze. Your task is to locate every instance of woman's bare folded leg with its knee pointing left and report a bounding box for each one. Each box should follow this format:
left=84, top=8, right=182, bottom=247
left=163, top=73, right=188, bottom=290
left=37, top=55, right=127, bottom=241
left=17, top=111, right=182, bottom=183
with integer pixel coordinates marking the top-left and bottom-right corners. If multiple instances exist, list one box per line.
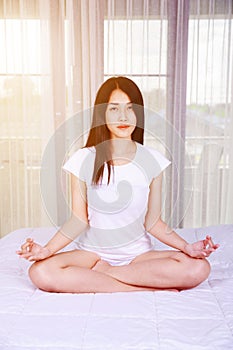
left=29, top=251, right=162, bottom=293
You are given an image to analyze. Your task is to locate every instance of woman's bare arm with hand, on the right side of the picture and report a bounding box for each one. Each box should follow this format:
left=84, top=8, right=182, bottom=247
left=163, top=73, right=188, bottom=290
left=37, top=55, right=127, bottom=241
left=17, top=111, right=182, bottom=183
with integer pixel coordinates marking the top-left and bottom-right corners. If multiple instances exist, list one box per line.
left=145, top=174, right=219, bottom=258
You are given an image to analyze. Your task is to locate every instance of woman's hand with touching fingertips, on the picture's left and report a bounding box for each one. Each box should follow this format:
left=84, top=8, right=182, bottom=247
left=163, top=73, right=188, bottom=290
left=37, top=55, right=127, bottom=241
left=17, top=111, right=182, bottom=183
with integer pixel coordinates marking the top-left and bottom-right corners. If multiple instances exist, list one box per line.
left=16, top=238, right=53, bottom=261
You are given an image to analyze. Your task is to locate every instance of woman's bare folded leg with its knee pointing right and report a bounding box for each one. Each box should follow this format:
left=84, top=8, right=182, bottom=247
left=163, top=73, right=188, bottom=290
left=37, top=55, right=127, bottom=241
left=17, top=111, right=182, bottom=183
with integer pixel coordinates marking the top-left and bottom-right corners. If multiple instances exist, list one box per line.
left=104, top=251, right=210, bottom=289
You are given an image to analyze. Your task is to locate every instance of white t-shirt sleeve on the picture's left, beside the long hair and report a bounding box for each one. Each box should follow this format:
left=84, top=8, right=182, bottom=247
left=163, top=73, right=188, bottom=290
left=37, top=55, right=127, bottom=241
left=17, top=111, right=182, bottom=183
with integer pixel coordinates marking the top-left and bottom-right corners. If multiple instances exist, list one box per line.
left=62, top=148, right=93, bottom=182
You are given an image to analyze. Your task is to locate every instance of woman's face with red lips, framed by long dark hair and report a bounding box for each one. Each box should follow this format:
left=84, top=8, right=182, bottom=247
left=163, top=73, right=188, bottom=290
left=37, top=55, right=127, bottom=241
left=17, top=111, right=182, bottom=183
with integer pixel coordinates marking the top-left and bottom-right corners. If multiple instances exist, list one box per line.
left=106, top=89, right=137, bottom=140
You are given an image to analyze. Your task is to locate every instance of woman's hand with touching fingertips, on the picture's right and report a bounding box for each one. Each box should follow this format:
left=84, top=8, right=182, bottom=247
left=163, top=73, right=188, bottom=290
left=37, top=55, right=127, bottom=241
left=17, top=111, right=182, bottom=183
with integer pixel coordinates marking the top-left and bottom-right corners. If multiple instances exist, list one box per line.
left=184, top=236, right=219, bottom=259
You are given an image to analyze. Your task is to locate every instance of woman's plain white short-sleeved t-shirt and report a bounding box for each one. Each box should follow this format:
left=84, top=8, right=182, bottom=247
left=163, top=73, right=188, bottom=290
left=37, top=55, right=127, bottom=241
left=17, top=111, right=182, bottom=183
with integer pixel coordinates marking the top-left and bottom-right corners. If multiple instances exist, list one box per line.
left=63, top=143, right=170, bottom=251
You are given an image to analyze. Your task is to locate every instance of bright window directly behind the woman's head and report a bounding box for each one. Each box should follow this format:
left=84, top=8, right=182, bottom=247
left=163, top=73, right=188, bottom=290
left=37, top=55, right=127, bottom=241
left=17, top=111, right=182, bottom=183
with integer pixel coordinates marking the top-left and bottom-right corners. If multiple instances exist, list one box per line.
left=104, top=18, right=167, bottom=154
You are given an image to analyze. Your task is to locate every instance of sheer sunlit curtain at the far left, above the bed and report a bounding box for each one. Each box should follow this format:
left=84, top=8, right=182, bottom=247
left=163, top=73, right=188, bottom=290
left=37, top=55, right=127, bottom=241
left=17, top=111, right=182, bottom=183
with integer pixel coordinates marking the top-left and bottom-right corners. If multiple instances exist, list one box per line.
left=0, top=1, right=53, bottom=236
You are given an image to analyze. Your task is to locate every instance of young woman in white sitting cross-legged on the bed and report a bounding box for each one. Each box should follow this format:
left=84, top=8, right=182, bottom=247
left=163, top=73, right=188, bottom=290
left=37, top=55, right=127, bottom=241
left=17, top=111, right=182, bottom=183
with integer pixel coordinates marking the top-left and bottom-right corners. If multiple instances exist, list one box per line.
left=17, top=77, right=218, bottom=293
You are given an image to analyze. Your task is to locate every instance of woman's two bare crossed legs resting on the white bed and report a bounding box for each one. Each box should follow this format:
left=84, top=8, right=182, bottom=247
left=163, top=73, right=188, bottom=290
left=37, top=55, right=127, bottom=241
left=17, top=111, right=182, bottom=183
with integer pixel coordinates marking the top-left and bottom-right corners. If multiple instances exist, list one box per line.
left=29, top=250, right=210, bottom=293
